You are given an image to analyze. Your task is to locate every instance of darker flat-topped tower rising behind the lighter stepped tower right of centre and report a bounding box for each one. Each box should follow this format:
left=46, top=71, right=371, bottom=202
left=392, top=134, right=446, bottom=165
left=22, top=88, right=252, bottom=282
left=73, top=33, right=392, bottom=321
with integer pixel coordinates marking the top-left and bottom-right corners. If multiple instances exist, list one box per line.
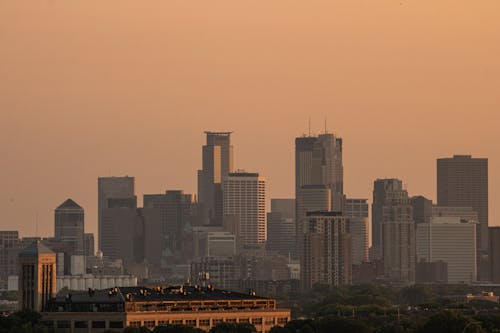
left=372, top=179, right=403, bottom=259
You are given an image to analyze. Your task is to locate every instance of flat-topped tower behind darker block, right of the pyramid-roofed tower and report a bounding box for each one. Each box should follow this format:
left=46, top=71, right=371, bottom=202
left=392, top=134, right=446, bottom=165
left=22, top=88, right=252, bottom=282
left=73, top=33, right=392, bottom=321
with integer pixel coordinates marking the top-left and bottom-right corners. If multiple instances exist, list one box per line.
left=97, top=176, right=135, bottom=250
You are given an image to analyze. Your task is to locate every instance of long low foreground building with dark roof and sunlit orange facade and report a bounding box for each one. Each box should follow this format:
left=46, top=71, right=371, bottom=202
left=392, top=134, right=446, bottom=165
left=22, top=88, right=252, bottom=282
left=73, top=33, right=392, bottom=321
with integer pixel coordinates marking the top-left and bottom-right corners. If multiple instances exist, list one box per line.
left=42, top=286, right=290, bottom=333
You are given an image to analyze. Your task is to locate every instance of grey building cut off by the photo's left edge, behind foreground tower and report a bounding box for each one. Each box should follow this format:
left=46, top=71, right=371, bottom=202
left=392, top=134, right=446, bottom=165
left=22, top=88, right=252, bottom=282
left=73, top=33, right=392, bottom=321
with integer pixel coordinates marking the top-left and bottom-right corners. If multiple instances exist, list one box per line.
left=0, top=231, right=20, bottom=290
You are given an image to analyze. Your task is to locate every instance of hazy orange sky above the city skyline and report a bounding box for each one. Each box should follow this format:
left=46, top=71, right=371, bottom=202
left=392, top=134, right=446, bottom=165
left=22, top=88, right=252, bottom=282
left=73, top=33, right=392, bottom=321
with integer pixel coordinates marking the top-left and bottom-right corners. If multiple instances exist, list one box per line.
left=0, top=0, right=500, bottom=236
